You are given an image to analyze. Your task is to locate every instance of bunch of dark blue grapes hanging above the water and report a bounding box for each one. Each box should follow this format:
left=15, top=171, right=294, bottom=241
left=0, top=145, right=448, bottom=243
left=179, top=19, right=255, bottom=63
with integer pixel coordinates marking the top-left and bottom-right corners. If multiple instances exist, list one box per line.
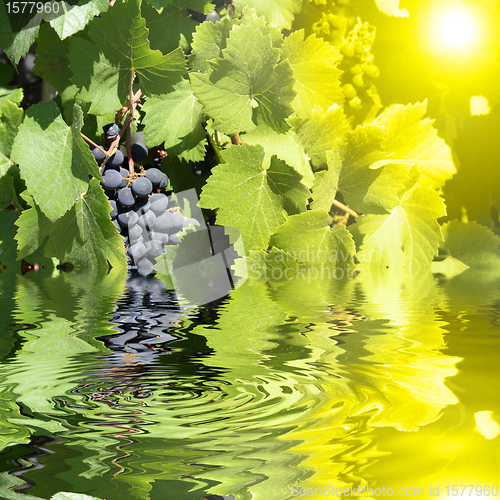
left=91, top=124, right=200, bottom=276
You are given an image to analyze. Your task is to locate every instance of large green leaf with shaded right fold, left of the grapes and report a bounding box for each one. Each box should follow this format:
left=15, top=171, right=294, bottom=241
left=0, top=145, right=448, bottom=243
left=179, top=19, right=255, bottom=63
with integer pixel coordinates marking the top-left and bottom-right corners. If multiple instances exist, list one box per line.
left=11, top=101, right=101, bottom=221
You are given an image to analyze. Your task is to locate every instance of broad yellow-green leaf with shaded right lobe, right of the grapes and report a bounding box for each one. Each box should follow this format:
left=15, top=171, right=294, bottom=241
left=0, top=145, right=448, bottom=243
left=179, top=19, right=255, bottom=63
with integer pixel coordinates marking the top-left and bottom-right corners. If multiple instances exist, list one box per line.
left=200, top=144, right=308, bottom=251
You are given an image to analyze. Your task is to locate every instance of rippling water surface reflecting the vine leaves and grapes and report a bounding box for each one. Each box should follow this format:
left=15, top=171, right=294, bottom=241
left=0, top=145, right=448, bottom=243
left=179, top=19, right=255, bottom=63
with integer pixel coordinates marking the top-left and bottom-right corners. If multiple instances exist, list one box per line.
left=0, top=272, right=500, bottom=500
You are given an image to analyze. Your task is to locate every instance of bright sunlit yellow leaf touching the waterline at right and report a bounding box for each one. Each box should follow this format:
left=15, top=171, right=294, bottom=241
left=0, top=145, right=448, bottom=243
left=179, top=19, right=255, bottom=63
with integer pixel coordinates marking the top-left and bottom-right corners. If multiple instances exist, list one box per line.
left=356, top=186, right=446, bottom=274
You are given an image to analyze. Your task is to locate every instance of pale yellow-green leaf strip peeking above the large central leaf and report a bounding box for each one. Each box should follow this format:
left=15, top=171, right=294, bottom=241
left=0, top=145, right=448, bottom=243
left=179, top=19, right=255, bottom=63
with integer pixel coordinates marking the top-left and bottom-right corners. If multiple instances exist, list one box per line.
left=241, top=119, right=314, bottom=188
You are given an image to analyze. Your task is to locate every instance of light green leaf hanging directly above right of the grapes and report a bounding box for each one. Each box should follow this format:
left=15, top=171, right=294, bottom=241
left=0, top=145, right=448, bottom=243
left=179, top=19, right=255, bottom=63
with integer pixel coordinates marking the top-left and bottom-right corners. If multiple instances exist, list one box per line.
left=142, top=80, right=207, bottom=161
